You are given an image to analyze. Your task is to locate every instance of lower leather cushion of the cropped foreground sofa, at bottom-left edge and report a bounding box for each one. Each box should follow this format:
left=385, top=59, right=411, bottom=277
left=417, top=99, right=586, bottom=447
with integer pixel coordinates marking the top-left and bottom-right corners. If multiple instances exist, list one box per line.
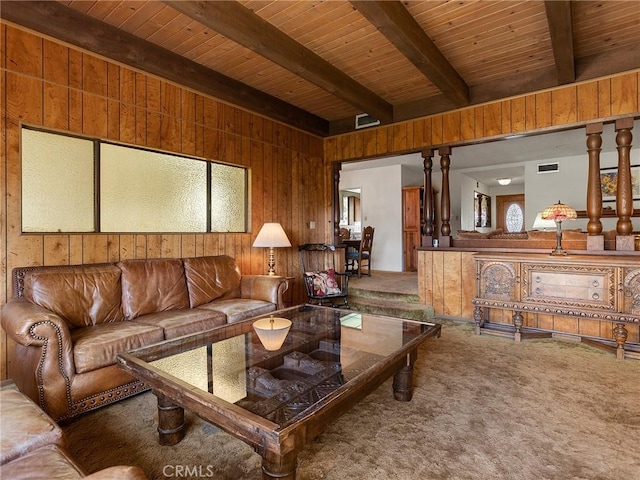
left=2, top=445, right=85, bottom=480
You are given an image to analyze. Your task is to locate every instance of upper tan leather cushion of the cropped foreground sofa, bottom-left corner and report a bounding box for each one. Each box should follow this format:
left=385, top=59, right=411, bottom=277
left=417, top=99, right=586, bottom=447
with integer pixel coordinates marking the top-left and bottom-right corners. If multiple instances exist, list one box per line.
left=0, top=388, right=64, bottom=464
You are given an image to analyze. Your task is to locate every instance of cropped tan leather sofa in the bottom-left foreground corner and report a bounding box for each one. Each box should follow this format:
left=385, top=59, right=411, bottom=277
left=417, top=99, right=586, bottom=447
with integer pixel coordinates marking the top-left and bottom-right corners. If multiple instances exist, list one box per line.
left=0, top=388, right=147, bottom=480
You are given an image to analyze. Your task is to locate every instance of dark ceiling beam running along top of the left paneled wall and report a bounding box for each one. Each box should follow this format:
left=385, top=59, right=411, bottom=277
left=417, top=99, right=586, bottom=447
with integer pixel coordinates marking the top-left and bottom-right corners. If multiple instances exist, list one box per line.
left=0, top=1, right=329, bottom=136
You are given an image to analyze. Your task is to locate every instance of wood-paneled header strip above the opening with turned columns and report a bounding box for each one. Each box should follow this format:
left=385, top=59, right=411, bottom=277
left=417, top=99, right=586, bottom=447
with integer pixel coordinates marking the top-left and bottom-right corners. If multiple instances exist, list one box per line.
left=325, top=70, right=640, bottom=161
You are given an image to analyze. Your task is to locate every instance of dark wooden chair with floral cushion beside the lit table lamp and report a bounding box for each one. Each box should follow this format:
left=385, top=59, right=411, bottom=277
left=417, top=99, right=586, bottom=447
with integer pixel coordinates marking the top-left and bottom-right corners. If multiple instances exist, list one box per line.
left=298, top=243, right=349, bottom=308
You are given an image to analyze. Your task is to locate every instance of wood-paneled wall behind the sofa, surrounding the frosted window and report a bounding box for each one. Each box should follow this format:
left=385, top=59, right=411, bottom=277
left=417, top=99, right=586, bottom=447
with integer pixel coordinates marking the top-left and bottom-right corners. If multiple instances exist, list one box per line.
left=0, top=23, right=333, bottom=378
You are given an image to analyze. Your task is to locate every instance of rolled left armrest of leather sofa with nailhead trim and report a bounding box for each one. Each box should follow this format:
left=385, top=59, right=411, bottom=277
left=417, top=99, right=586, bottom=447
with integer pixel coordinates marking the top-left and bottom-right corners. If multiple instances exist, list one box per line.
left=2, top=297, right=75, bottom=420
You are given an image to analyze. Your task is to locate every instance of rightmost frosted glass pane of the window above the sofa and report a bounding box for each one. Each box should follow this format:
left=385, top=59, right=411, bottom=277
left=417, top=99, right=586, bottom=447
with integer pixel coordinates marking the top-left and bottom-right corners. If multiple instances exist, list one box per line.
left=211, top=163, right=247, bottom=232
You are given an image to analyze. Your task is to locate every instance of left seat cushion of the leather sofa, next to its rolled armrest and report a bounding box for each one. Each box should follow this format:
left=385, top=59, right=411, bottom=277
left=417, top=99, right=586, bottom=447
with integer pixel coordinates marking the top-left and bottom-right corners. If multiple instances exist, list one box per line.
left=71, top=322, right=164, bottom=373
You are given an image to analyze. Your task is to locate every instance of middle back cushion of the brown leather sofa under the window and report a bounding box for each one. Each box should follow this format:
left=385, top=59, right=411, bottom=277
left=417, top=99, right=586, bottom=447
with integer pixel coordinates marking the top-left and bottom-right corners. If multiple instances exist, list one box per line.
left=118, top=258, right=189, bottom=320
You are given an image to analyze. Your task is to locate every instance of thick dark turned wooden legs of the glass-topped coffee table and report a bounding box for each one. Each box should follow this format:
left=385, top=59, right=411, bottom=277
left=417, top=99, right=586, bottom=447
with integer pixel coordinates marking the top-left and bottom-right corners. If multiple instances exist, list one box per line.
left=153, top=349, right=418, bottom=480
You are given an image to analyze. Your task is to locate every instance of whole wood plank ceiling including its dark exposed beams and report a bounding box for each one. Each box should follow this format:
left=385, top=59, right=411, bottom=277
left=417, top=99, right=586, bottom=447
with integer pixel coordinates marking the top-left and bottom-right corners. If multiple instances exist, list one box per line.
left=0, top=0, right=640, bottom=136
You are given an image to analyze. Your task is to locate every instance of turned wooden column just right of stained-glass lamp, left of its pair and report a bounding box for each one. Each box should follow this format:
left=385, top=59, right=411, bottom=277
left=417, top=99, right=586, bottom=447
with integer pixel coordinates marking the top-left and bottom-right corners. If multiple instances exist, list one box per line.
left=586, top=123, right=604, bottom=250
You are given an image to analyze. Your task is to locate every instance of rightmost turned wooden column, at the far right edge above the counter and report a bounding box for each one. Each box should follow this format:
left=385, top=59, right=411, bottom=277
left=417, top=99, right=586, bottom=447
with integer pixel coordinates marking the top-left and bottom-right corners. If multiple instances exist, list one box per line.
left=616, top=117, right=634, bottom=250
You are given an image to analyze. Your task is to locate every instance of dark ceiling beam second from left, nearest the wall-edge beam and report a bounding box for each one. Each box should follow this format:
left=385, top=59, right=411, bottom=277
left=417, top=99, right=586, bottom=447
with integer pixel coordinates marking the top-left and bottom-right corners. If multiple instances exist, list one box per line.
left=164, top=0, right=393, bottom=123
